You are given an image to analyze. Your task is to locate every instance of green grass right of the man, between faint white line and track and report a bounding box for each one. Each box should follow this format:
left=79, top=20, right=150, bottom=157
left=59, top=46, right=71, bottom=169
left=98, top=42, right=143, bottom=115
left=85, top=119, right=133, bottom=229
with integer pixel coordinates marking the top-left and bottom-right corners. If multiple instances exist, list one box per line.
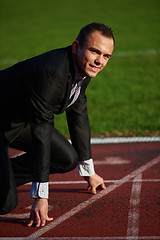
left=88, top=54, right=160, bottom=135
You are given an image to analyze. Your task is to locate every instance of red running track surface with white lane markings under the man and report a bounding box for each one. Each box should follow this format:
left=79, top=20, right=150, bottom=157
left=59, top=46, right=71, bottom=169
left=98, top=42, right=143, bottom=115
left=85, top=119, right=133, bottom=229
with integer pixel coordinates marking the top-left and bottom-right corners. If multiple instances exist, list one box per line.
left=0, top=142, right=160, bottom=240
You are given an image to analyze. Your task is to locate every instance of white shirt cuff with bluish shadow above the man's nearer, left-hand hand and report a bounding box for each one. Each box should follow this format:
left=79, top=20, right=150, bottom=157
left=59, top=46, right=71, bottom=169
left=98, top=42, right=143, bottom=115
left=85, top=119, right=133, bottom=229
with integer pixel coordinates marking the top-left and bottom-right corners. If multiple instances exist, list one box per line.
left=30, top=182, right=48, bottom=199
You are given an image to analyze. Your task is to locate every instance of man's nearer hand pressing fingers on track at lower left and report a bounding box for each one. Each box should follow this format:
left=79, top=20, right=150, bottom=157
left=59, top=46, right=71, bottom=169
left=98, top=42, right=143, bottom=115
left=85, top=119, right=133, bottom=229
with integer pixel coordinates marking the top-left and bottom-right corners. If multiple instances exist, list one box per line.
left=27, top=198, right=53, bottom=227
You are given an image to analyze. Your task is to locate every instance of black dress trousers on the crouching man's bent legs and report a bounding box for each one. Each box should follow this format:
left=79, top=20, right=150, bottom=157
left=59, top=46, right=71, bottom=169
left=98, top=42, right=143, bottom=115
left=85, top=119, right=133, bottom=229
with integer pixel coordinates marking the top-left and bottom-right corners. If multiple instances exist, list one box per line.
left=0, top=125, right=78, bottom=214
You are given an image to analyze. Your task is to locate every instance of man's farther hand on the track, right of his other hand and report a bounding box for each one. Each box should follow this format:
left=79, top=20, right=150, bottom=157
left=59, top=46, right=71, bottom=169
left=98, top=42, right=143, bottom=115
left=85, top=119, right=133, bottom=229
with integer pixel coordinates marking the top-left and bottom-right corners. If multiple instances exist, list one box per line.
left=84, top=173, right=106, bottom=194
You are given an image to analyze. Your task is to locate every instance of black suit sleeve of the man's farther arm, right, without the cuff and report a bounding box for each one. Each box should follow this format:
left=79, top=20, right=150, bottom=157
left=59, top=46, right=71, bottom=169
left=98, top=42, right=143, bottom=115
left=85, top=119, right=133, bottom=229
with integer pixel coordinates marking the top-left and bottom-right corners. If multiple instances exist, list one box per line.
left=66, top=79, right=92, bottom=161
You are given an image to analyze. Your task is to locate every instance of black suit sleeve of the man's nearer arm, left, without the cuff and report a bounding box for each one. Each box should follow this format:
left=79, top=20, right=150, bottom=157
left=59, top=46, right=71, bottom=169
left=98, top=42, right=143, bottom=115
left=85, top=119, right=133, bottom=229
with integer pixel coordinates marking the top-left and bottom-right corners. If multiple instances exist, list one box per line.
left=26, top=68, right=59, bottom=182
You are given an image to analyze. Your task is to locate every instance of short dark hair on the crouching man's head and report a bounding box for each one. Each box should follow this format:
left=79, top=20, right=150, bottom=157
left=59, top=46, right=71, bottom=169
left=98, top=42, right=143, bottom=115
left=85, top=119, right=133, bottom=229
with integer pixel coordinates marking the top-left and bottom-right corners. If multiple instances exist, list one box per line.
left=76, top=22, right=115, bottom=47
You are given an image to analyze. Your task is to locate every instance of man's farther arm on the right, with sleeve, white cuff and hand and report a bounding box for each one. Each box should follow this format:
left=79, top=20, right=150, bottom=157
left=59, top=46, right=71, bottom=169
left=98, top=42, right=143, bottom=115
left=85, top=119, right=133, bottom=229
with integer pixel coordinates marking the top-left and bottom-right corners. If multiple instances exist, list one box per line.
left=66, top=79, right=106, bottom=194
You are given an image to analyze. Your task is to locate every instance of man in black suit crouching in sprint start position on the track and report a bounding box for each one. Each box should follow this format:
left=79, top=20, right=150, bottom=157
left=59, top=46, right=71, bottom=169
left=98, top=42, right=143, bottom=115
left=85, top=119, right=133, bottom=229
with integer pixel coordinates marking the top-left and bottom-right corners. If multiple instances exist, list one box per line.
left=0, top=23, right=114, bottom=227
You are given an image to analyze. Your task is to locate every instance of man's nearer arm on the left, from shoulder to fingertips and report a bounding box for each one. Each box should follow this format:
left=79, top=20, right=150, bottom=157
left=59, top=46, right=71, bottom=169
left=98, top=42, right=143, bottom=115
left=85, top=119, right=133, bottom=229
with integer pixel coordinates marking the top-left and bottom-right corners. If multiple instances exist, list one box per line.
left=27, top=67, right=59, bottom=227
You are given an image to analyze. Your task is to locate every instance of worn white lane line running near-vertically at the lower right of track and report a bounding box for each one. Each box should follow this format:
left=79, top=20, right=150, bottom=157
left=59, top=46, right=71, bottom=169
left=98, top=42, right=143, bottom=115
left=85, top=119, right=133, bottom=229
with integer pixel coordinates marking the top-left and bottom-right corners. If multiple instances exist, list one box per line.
left=127, top=173, right=142, bottom=240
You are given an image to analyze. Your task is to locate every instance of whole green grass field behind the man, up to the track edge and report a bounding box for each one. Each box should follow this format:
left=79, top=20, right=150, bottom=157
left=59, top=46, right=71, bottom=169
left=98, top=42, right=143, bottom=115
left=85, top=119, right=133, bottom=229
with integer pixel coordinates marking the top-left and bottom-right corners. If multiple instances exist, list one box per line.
left=0, top=0, right=160, bottom=136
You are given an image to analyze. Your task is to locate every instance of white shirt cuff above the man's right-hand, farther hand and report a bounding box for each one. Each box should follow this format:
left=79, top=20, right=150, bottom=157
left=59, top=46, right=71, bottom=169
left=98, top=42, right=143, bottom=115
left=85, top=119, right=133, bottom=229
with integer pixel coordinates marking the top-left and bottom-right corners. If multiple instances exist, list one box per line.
left=78, top=158, right=95, bottom=177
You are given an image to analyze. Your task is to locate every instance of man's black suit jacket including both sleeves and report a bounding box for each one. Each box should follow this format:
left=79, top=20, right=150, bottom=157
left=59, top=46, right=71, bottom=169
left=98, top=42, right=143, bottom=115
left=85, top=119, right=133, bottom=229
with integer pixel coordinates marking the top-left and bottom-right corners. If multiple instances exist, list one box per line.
left=0, top=46, right=91, bottom=182
